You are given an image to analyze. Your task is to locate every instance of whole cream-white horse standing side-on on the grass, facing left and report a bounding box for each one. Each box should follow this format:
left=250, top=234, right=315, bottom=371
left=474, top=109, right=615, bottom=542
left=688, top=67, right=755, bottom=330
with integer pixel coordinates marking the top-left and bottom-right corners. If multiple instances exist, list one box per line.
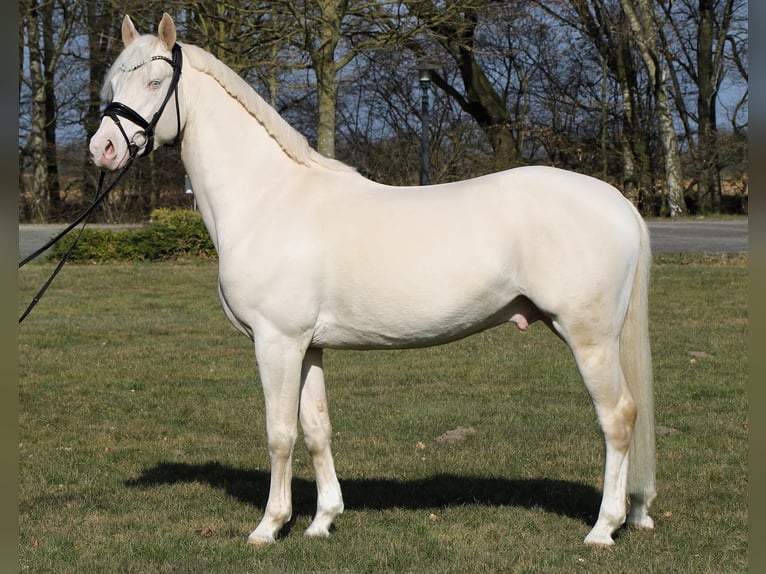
left=90, top=14, right=655, bottom=545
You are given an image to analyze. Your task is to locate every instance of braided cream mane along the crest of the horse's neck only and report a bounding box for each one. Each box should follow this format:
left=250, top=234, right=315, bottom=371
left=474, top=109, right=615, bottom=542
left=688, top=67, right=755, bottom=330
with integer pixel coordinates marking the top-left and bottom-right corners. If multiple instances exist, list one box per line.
left=181, top=44, right=356, bottom=171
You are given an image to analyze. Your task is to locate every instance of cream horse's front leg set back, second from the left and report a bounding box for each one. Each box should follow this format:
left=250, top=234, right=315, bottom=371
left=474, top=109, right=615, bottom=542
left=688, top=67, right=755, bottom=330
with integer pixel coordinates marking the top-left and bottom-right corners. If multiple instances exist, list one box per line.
left=300, top=349, right=343, bottom=536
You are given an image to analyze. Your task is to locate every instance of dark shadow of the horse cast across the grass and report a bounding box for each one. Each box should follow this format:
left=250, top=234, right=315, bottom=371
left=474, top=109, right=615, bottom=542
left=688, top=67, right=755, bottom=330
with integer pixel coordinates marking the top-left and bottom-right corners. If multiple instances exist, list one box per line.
left=125, top=461, right=601, bottom=524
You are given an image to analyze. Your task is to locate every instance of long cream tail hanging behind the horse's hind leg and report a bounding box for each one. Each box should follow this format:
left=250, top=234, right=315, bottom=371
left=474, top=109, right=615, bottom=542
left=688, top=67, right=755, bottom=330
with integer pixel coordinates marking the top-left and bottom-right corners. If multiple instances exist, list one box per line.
left=620, top=212, right=656, bottom=508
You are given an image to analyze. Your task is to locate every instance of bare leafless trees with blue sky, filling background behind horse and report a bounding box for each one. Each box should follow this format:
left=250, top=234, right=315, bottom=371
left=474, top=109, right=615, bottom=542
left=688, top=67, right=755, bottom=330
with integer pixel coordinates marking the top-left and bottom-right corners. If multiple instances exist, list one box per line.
left=19, top=0, right=747, bottom=223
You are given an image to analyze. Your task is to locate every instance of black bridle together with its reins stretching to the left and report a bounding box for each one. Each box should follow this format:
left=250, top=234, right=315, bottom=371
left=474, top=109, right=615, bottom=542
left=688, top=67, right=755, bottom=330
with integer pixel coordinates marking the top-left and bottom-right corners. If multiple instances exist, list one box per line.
left=19, top=44, right=183, bottom=323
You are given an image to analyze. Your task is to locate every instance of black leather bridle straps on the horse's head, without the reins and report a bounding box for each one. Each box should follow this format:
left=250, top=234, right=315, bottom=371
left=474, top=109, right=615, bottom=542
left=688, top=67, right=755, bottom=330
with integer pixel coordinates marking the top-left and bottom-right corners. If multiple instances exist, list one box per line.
left=102, top=44, right=183, bottom=157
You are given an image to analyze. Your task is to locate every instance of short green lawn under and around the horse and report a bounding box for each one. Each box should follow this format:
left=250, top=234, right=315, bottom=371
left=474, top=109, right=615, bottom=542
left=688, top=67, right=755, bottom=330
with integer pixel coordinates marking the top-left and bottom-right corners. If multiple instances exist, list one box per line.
left=19, top=256, right=748, bottom=574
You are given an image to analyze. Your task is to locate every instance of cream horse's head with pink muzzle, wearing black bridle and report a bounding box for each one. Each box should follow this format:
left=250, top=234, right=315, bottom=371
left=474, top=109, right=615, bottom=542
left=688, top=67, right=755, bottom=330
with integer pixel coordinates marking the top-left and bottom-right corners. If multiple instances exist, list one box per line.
left=90, top=14, right=182, bottom=170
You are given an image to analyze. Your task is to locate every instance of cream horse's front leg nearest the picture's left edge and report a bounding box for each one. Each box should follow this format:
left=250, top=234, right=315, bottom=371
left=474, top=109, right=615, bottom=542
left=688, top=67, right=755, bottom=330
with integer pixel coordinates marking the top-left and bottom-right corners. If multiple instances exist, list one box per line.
left=247, top=336, right=305, bottom=545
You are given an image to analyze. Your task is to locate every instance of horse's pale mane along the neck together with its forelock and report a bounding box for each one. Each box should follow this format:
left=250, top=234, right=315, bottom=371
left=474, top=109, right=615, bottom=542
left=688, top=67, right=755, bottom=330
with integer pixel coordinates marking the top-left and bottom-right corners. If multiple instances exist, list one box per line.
left=101, top=35, right=356, bottom=172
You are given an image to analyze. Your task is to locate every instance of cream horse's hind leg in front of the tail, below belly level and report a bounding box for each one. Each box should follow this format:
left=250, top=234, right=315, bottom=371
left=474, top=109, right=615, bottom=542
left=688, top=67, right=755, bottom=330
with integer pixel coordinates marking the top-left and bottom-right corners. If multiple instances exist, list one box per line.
left=572, top=342, right=636, bottom=546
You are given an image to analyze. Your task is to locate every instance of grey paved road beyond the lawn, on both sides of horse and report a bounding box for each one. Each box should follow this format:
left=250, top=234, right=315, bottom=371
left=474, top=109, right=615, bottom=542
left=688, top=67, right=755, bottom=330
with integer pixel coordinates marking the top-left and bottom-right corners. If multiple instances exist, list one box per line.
left=19, top=219, right=748, bottom=259
